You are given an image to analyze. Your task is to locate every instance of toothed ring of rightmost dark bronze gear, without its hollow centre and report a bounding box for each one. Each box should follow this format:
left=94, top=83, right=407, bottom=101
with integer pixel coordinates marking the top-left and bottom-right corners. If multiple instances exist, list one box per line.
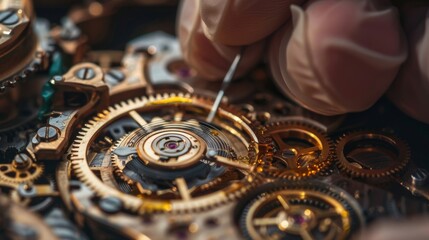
left=335, top=130, right=410, bottom=182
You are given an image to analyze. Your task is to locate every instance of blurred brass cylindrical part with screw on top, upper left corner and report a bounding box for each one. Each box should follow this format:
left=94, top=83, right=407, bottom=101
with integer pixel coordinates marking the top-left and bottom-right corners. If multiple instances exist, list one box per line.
left=0, top=0, right=49, bottom=92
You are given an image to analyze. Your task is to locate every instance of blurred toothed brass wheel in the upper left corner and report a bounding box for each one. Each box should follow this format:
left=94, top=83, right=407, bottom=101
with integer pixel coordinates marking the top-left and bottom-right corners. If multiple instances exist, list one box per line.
left=0, top=6, right=54, bottom=94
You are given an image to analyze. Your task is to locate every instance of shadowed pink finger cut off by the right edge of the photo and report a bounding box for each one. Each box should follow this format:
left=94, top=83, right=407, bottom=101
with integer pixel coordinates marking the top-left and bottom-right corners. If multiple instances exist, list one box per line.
left=388, top=4, right=429, bottom=123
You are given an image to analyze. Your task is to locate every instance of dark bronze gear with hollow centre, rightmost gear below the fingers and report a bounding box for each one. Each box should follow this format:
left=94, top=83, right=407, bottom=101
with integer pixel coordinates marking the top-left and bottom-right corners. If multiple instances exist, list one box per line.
left=336, top=130, right=410, bottom=180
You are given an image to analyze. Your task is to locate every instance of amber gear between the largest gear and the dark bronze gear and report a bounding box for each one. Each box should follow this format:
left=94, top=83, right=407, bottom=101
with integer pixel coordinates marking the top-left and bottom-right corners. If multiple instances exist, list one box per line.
left=264, top=121, right=334, bottom=180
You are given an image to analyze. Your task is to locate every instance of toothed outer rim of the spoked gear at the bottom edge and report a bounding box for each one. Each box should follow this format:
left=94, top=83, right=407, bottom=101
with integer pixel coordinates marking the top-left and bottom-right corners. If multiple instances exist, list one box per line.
left=236, top=180, right=365, bottom=239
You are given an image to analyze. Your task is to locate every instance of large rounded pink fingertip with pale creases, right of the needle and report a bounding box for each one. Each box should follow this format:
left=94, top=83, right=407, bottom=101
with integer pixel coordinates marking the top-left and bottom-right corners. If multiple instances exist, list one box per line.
left=269, top=0, right=407, bottom=115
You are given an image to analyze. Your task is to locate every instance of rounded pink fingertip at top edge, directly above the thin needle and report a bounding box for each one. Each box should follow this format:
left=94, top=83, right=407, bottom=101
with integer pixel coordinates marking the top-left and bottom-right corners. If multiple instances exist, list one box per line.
left=200, top=0, right=305, bottom=46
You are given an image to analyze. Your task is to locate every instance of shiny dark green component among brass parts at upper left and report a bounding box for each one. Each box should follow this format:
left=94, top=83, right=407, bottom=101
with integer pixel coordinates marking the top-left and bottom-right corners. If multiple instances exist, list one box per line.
left=37, top=52, right=66, bottom=121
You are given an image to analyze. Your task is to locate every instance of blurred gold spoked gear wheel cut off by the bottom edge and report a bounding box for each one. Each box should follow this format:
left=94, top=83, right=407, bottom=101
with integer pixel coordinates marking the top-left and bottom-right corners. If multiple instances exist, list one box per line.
left=237, top=181, right=364, bottom=240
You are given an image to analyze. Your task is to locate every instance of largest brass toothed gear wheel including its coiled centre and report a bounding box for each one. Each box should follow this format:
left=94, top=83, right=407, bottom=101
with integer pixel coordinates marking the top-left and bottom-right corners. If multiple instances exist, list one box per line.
left=71, top=94, right=260, bottom=213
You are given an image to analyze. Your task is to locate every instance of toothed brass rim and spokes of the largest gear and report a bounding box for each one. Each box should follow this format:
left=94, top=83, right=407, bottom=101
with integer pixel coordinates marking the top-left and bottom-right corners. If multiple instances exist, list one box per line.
left=70, top=93, right=265, bottom=213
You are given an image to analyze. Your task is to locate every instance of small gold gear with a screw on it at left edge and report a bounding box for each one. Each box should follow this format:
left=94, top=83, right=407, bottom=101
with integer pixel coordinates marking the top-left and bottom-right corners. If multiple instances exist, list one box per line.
left=0, top=153, right=43, bottom=185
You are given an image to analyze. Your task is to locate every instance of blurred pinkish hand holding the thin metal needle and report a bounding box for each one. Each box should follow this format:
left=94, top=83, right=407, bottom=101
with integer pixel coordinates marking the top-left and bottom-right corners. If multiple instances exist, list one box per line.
left=177, top=0, right=429, bottom=123
